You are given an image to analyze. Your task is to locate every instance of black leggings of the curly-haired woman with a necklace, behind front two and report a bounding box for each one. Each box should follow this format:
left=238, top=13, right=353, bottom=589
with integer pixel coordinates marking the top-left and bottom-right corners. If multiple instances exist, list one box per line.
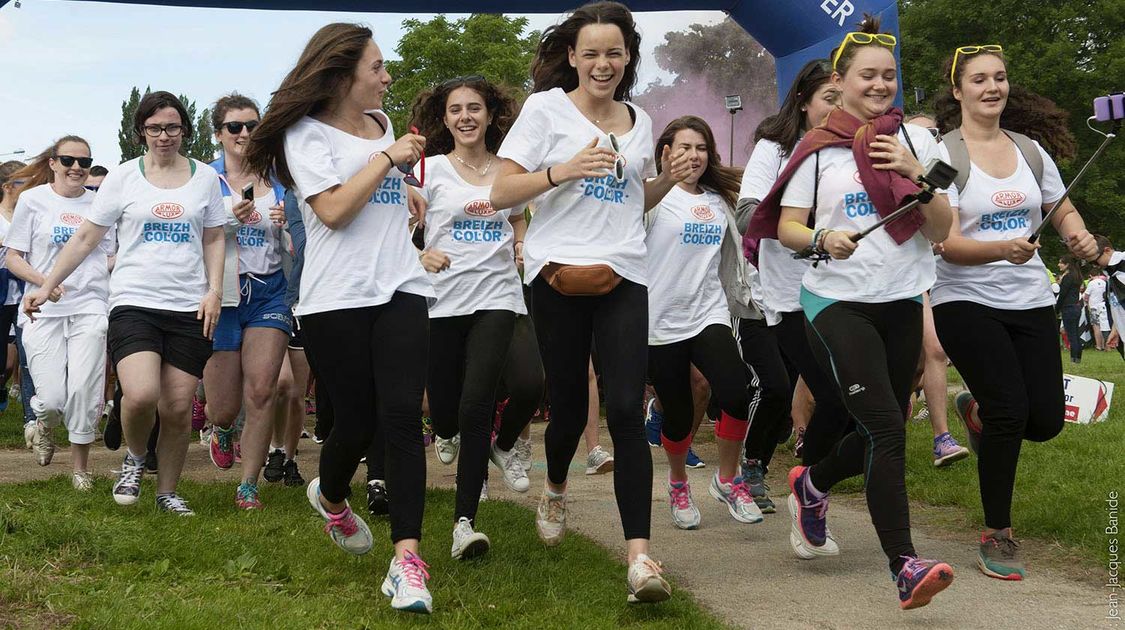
left=426, top=311, right=515, bottom=522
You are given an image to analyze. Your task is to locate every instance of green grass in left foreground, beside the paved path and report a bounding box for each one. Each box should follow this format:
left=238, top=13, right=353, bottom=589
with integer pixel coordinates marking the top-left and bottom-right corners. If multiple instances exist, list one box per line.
left=0, top=477, right=722, bottom=630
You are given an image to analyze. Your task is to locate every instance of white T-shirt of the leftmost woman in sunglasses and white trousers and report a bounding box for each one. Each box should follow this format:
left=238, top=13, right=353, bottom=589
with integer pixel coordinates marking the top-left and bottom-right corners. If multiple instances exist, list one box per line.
left=5, top=185, right=116, bottom=326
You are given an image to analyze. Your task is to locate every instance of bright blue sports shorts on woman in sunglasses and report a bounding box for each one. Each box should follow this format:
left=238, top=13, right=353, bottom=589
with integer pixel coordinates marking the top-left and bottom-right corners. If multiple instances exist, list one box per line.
left=214, top=271, right=293, bottom=352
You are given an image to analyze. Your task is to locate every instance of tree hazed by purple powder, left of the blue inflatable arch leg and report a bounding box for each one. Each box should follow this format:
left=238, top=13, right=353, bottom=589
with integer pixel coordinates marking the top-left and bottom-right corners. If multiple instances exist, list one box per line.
left=635, top=18, right=777, bottom=165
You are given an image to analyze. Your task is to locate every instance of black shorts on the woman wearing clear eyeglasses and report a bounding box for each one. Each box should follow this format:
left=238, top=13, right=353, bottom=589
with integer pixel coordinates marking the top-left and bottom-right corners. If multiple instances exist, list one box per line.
left=107, top=306, right=212, bottom=378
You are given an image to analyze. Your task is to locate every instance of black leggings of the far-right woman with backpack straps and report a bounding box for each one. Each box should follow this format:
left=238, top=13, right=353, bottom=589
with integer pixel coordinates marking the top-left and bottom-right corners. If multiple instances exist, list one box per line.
left=934, top=302, right=1065, bottom=530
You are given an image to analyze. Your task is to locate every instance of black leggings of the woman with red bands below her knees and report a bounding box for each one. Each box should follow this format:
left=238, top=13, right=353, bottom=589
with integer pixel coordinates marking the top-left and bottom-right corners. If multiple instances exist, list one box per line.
left=648, top=324, right=750, bottom=452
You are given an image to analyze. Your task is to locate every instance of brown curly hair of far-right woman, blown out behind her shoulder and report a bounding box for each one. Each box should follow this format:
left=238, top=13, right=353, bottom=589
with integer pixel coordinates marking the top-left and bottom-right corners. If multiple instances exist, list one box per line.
left=934, top=51, right=1078, bottom=160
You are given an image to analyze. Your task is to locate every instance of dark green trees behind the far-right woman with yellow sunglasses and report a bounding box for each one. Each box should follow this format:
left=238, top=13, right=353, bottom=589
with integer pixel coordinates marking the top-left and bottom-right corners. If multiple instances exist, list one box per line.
left=899, top=0, right=1125, bottom=256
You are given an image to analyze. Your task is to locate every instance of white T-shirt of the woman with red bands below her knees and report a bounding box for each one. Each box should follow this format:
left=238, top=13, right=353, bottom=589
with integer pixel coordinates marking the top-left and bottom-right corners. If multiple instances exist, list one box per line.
left=645, top=186, right=730, bottom=345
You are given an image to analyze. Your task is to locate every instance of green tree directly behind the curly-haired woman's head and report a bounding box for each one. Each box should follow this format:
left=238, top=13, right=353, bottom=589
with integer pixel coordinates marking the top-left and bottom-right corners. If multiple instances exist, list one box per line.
left=384, top=14, right=539, bottom=133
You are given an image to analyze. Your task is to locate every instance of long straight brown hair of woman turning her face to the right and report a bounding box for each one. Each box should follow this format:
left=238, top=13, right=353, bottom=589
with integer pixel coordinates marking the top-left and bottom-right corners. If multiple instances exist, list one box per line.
left=243, top=23, right=372, bottom=188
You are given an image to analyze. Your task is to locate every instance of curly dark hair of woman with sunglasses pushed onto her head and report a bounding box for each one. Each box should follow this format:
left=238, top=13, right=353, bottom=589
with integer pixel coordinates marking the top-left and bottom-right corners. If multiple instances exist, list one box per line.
left=411, top=77, right=519, bottom=155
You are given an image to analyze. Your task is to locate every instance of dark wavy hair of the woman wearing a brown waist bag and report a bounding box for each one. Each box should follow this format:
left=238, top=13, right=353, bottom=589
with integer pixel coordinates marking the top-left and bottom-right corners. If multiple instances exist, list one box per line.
left=531, top=2, right=640, bottom=100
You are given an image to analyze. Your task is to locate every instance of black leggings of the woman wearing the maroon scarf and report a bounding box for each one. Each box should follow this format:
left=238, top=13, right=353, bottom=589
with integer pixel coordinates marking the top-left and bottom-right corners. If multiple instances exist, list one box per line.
left=808, top=299, right=921, bottom=575
